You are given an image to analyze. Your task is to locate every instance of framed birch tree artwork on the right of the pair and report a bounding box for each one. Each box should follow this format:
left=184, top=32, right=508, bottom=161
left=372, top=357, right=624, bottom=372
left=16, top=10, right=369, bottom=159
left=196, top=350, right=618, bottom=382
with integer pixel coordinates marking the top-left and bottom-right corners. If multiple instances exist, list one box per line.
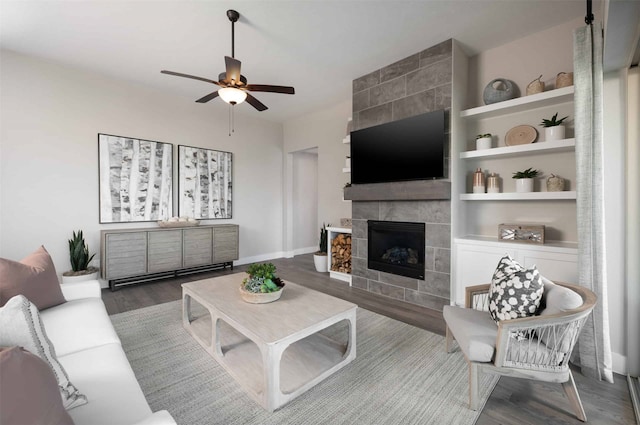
left=178, top=145, right=233, bottom=220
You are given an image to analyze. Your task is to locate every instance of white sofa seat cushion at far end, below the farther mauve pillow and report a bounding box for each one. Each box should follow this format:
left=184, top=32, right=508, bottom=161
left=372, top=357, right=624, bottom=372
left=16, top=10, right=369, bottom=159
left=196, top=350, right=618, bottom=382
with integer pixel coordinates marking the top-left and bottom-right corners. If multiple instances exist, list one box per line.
left=40, top=296, right=120, bottom=357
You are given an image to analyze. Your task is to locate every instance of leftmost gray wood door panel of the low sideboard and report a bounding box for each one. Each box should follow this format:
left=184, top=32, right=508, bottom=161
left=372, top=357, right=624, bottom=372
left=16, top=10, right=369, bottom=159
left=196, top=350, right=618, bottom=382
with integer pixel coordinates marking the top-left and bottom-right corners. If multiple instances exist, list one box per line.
left=104, top=232, right=147, bottom=280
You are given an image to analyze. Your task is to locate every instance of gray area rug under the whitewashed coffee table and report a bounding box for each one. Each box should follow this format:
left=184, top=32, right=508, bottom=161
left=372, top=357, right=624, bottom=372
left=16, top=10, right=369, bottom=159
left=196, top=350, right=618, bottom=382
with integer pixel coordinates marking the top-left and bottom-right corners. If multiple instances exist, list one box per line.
left=111, top=301, right=498, bottom=425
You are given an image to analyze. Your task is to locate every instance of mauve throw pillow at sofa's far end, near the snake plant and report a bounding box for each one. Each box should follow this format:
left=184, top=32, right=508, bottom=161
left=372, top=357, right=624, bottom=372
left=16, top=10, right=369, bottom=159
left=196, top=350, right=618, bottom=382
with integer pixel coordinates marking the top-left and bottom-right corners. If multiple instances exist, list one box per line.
left=0, top=246, right=65, bottom=310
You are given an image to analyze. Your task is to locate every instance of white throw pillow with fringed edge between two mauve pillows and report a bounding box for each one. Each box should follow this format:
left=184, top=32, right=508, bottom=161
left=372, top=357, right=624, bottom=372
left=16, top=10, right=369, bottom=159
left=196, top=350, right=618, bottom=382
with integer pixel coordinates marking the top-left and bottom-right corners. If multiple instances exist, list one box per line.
left=0, top=295, right=87, bottom=410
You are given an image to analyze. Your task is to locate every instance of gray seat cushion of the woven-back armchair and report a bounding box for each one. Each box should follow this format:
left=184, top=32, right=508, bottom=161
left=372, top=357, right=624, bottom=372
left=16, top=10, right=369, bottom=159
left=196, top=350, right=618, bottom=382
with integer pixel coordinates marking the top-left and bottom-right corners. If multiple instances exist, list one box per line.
left=442, top=305, right=498, bottom=363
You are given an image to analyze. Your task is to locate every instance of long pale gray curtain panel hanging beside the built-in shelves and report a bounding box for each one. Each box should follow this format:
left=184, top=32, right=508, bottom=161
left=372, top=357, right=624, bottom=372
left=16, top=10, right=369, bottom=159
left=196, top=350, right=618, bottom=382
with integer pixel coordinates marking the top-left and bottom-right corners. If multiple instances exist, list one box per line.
left=573, top=23, right=613, bottom=382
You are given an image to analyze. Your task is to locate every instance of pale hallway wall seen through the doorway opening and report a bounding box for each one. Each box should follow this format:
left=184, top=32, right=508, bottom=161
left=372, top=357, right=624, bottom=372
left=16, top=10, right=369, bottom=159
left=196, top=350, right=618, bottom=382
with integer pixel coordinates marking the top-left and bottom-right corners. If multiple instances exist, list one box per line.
left=292, top=149, right=318, bottom=254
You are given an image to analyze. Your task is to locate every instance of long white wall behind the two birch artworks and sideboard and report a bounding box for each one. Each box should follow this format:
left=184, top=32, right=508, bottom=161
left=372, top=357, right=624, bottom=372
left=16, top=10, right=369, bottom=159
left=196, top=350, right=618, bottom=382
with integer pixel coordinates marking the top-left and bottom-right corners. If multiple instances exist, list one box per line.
left=0, top=51, right=283, bottom=274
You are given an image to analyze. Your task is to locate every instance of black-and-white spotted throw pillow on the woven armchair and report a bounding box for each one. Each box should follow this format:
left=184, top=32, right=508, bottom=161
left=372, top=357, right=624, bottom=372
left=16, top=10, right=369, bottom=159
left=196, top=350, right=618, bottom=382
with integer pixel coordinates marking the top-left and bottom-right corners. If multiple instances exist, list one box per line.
left=489, top=255, right=544, bottom=322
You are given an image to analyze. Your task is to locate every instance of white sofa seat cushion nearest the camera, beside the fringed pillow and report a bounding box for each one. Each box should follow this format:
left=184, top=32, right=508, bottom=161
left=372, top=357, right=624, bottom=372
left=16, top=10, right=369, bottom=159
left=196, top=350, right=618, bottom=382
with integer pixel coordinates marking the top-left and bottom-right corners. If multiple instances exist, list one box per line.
left=60, top=344, right=151, bottom=425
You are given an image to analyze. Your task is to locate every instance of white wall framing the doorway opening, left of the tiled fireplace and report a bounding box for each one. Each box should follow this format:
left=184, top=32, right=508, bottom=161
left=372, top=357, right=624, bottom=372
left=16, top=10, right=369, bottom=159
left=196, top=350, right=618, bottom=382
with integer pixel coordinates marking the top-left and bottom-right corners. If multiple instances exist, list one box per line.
left=283, top=97, right=351, bottom=255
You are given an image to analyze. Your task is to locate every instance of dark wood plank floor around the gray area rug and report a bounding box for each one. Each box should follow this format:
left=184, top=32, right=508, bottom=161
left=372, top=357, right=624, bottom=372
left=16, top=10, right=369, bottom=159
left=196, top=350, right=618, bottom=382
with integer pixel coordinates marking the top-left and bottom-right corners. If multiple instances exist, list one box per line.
left=102, top=254, right=635, bottom=425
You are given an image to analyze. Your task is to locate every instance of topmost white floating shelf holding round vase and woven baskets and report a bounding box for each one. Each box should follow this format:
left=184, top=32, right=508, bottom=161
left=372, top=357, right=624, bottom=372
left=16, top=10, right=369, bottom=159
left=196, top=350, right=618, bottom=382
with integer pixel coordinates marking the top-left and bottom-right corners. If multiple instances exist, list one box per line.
left=460, top=86, right=573, bottom=119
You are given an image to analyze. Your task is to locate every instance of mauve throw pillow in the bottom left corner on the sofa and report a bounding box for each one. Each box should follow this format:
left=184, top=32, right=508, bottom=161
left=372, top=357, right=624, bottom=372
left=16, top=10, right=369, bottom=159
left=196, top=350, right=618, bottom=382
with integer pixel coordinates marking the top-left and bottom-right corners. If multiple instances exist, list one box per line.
left=0, top=347, right=73, bottom=425
